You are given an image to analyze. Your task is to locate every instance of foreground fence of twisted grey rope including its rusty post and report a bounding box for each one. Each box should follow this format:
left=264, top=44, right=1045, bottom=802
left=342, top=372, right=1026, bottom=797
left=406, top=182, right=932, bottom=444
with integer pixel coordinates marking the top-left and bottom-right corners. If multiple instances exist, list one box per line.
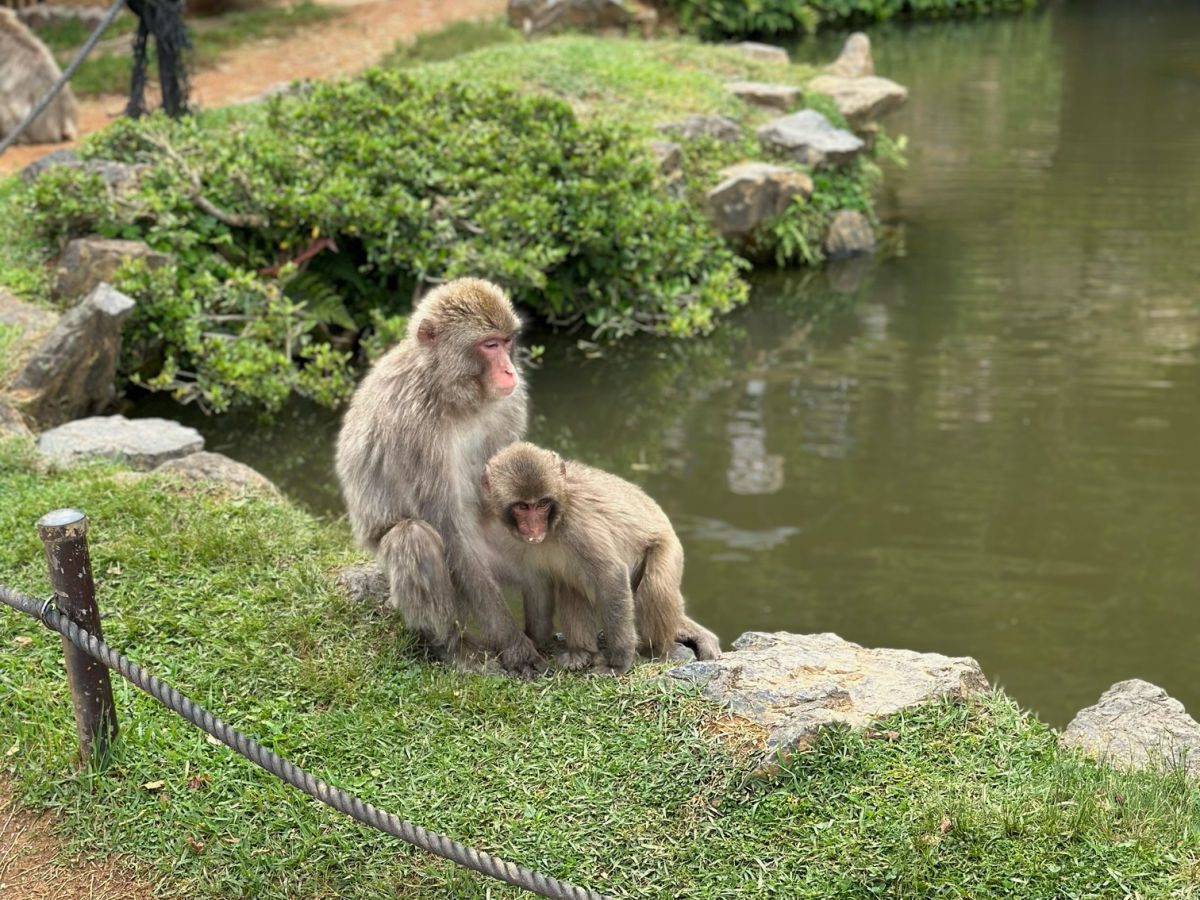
left=0, top=510, right=610, bottom=900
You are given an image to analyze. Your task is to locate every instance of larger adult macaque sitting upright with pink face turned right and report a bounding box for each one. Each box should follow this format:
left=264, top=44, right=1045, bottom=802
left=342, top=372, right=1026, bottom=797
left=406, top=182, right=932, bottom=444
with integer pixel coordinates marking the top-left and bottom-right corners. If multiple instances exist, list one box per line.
left=337, top=278, right=546, bottom=676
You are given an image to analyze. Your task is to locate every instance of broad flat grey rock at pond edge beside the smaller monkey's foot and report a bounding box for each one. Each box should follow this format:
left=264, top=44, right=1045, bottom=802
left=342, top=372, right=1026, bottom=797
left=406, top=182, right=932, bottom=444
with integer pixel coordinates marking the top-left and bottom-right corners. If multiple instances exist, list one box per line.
left=670, top=631, right=988, bottom=762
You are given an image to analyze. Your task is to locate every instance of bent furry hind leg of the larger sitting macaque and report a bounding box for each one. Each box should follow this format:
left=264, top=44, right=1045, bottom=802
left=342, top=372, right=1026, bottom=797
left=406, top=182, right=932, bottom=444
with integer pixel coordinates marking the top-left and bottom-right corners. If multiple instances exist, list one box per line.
left=376, top=518, right=462, bottom=661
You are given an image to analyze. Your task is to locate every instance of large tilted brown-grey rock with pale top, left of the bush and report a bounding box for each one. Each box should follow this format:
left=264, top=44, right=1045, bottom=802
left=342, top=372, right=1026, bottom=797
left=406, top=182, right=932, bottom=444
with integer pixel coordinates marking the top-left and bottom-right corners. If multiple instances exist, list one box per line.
left=10, top=284, right=134, bottom=427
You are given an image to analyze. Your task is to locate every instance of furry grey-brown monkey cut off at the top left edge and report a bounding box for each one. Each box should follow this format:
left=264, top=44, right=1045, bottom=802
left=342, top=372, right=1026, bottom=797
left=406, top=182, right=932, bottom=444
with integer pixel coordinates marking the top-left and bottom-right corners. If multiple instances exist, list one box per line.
left=0, top=8, right=79, bottom=144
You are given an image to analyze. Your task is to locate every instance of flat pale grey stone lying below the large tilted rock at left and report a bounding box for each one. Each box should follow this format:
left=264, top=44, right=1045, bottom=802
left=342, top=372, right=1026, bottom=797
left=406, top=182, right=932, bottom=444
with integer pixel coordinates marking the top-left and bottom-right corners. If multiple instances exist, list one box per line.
left=37, top=415, right=204, bottom=469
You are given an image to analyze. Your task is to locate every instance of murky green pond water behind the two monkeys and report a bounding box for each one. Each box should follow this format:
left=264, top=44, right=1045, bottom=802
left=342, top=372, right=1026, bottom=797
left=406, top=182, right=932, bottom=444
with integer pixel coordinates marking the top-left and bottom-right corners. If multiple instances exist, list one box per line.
left=139, top=0, right=1200, bottom=726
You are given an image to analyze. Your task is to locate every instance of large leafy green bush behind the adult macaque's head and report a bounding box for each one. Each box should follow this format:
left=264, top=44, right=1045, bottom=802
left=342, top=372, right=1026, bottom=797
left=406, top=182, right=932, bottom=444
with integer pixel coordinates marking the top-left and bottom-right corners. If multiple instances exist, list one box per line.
left=23, top=71, right=746, bottom=410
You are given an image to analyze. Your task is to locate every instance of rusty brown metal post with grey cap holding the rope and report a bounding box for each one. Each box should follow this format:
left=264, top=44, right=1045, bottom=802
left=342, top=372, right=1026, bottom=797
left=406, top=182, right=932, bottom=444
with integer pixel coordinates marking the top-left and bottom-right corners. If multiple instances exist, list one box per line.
left=37, top=509, right=116, bottom=761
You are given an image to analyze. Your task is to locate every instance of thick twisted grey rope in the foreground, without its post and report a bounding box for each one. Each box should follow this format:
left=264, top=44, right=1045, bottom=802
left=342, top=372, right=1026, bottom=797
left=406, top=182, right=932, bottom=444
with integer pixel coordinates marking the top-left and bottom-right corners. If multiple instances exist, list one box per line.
left=0, top=584, right=610, bottom=900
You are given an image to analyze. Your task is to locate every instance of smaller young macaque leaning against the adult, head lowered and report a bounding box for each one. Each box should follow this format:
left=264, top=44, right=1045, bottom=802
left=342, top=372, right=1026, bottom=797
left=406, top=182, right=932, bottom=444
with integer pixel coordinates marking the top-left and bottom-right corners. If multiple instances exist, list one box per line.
left=482, top=443, right=700, bottom=673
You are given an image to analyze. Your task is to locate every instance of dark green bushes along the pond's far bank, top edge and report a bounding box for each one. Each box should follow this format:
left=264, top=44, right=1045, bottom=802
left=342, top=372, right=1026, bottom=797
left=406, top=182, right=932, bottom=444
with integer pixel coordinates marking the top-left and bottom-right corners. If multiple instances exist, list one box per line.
left=662, top=0, right=1040, bottom=38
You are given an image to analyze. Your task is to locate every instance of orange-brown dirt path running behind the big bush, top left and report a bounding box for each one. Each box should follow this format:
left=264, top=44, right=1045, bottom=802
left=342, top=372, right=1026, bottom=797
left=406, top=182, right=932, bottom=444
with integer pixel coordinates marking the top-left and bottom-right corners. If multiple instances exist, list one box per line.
left=0, top=0, right=505, bottom=175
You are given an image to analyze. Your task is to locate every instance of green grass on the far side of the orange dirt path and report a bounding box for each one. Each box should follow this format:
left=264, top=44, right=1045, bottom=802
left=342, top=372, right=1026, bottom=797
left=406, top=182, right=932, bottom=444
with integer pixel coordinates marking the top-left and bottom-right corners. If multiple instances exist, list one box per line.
left=46, top=0, right=346, bottom=97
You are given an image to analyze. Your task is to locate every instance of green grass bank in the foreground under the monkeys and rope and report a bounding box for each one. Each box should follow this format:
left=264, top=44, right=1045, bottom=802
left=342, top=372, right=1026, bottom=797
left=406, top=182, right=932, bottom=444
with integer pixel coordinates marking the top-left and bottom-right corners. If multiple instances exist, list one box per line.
left=0, top=440, right=1200, bottom=899
